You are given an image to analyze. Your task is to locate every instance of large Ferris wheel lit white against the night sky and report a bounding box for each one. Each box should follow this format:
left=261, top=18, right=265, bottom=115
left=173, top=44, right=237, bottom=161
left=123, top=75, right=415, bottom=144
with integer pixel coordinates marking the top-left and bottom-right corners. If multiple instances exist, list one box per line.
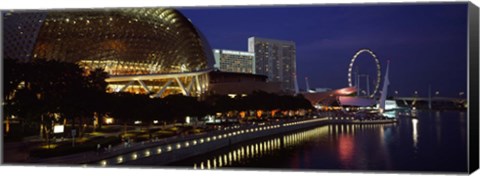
left=348, top=49, right=382, bottom=98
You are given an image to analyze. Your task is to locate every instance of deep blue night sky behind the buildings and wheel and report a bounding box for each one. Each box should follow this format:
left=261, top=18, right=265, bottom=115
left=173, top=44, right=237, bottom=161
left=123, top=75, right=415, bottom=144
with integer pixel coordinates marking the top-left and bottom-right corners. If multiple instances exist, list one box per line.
left=180, top=3, right=467, bottom=97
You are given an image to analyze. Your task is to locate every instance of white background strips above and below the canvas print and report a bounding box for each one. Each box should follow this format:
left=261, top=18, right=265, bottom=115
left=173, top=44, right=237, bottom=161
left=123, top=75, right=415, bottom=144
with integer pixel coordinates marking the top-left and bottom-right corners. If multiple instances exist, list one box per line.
left=0, top=0, right=480, bottom=176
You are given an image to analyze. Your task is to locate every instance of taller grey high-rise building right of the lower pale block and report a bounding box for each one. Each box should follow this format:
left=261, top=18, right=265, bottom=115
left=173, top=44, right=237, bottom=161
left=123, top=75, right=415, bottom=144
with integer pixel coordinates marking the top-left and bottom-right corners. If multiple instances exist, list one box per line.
left=248, top=37, right=296, bottom=92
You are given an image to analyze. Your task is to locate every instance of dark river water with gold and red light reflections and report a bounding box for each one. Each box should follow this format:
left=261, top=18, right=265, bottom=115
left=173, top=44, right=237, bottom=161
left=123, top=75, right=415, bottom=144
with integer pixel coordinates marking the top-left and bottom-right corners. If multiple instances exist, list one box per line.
left=172, top=111, right=467, bottom=172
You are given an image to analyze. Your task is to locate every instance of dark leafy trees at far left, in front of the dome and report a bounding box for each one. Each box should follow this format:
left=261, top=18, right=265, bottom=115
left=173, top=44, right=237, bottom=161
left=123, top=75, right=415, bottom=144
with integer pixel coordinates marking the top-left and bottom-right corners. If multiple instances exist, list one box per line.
left=4, top=59, right=110, bottom=142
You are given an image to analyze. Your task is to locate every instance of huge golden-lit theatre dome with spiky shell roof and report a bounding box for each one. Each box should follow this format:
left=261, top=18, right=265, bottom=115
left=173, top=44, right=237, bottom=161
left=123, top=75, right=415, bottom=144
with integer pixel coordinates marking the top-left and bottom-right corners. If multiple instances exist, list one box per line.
left=2, top=8, right=214, bottom=97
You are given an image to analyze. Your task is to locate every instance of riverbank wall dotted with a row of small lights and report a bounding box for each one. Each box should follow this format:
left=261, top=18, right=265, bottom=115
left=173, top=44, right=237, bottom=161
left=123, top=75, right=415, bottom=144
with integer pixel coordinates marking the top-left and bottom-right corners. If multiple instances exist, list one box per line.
left=96, top=118, right=330, bottom=166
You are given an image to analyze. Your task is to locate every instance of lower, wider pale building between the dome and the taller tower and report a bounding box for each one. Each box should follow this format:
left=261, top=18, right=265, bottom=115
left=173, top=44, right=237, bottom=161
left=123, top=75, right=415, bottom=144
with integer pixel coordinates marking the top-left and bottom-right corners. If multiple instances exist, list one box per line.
left=213, top=49, right=255, bottom=74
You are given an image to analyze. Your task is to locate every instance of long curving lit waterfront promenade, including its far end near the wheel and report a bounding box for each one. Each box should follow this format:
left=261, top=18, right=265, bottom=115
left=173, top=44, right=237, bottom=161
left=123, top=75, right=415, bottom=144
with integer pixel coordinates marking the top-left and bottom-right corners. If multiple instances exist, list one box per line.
left=25, top=117, right=396, bottom=166
